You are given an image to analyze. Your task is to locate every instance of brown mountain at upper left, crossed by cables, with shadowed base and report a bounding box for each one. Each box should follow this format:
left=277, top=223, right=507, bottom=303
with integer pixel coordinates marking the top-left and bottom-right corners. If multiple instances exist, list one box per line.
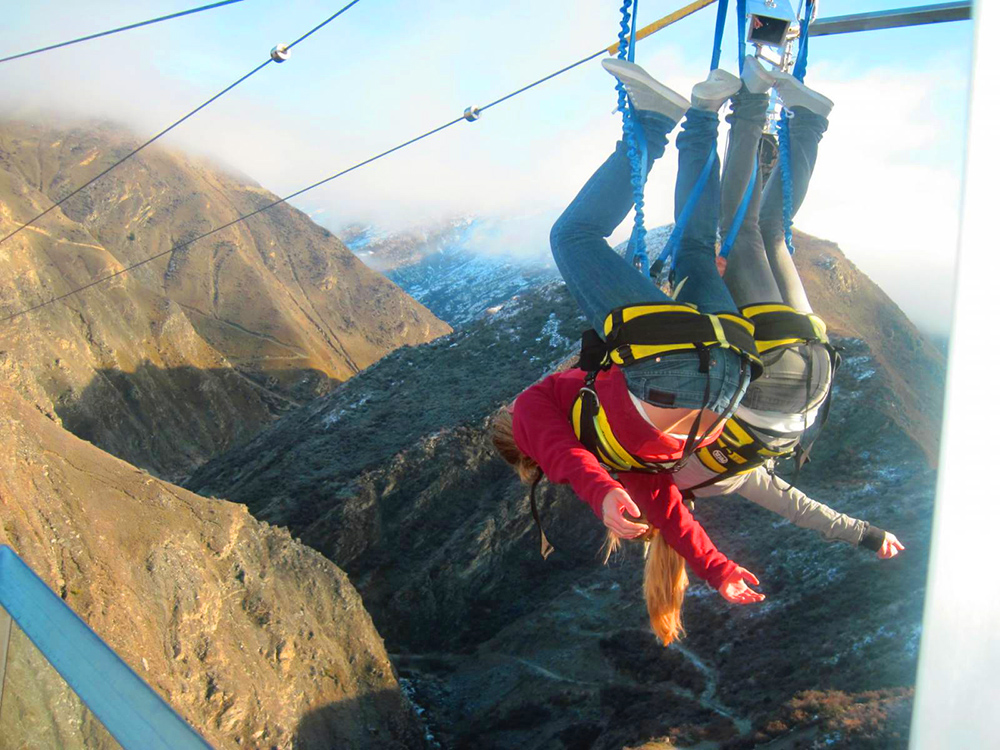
left=0, top=121, right=449, bottom=476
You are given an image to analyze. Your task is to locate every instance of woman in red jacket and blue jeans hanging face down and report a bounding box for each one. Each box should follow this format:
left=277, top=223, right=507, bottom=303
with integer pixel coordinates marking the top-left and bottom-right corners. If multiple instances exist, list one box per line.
left=495, top=60, right=764, bottom=643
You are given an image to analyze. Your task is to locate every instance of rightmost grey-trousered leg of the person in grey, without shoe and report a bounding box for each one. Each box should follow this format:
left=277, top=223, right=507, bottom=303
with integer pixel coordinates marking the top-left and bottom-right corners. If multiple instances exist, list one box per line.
left=760, top=89, right=832, bottom=312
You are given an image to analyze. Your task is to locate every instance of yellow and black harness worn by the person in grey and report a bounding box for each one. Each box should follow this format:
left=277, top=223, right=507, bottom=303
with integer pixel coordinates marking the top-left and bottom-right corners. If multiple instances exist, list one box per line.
left=683, top=303, right=840, bottom=499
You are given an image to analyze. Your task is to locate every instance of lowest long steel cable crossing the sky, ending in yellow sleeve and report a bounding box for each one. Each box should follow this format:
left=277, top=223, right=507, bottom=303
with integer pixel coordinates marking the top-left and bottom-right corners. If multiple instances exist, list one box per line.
left=0, top=0, right=717, bottom=324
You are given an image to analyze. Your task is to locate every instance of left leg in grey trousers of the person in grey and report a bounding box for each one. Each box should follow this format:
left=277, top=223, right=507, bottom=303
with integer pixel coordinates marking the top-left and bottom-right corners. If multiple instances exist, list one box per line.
left=721, top=87, right=782, bottom=308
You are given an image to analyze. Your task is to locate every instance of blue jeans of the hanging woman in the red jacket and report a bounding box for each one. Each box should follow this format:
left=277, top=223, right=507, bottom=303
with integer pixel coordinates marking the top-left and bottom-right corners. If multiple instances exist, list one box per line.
left=550, top=110, right=746, bottom=413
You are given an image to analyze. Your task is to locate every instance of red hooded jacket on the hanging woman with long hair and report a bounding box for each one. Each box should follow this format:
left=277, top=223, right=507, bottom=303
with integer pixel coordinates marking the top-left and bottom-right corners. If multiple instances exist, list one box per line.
left=514, top=367, right=736, bottom=588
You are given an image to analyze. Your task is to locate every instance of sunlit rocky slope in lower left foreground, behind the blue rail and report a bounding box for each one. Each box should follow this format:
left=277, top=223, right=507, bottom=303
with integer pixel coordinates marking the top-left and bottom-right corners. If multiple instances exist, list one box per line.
left=0, top=386, right=424, bottom=750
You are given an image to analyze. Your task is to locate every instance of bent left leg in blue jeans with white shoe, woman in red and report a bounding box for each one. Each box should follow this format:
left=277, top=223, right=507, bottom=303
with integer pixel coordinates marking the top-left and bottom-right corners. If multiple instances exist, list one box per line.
left=550, top=60, right=687, bottom=335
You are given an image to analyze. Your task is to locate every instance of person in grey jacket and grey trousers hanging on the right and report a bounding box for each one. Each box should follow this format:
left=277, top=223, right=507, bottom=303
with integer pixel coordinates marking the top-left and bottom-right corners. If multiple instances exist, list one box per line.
left=674, top=56, right=904, bottom=559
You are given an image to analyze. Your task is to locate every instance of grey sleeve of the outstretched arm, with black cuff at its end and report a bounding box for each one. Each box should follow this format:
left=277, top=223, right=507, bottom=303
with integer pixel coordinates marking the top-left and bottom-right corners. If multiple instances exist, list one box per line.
left=737, top=466, right=869, bottom=547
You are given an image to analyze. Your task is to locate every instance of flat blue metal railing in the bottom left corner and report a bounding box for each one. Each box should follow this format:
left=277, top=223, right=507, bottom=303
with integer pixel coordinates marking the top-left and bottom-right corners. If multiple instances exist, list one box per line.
left=0, top=545, right=212, bottom=750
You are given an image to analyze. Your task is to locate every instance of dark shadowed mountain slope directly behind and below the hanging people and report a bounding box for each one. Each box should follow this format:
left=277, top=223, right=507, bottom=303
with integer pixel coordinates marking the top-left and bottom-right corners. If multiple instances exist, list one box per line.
left=189, top=229, right=943, bottom=750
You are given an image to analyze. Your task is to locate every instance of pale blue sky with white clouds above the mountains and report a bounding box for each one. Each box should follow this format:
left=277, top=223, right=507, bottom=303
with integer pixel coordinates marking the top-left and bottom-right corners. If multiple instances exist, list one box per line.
left=0, top=0, right=972, bottom=331
